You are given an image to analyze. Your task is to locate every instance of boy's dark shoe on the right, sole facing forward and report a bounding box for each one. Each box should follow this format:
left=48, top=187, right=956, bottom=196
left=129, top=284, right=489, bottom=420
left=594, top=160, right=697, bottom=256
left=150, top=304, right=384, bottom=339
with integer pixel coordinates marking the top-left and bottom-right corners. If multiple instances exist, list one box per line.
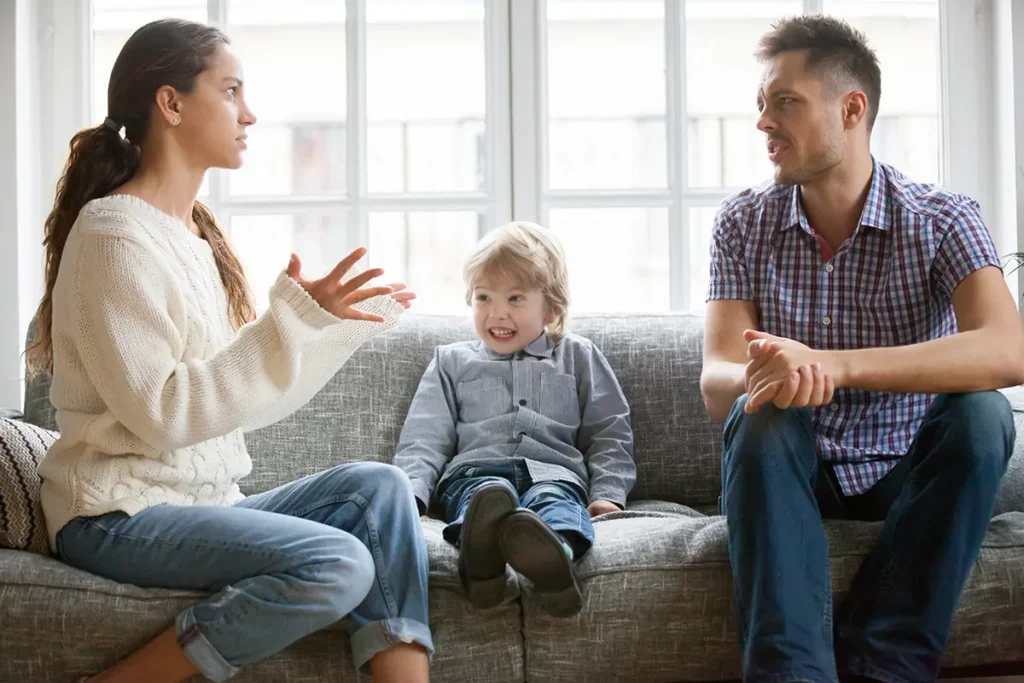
left=500, top=508, right=583, bottom=617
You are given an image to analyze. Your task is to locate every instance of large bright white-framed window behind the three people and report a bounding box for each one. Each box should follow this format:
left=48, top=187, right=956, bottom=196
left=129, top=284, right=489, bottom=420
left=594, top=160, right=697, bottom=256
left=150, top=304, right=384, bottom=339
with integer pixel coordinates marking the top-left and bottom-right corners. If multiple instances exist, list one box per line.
left=90, top=0, right=942, bottom=313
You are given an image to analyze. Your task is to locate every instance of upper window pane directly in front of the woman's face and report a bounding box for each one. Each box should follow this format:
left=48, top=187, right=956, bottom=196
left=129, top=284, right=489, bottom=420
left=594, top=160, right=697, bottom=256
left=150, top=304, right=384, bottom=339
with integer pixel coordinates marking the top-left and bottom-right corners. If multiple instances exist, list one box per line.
left=227, top=0, right=346, bottom=196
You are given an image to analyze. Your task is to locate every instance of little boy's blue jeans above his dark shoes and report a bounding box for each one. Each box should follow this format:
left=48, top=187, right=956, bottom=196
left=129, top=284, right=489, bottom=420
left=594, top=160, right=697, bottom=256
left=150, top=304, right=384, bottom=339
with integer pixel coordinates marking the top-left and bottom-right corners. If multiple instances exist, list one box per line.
left=437, top=461, right=594, bottom=560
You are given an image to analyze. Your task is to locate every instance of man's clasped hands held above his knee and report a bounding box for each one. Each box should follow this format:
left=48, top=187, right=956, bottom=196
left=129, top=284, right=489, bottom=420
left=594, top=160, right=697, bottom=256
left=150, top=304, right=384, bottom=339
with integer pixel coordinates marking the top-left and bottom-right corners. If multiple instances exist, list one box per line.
left=743, top=330, right=836, bottom=413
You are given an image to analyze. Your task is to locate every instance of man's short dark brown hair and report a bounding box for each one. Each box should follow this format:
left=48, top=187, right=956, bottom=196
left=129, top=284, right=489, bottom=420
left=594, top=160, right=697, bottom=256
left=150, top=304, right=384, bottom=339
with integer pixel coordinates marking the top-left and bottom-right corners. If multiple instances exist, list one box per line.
left=755, top=14, right=882, bottom=132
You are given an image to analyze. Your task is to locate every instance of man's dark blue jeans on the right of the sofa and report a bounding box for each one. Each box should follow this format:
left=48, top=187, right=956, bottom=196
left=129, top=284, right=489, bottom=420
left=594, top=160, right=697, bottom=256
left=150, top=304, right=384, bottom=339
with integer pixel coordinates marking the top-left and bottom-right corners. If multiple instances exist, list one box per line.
left=722, top=391, right=1014, bottom=683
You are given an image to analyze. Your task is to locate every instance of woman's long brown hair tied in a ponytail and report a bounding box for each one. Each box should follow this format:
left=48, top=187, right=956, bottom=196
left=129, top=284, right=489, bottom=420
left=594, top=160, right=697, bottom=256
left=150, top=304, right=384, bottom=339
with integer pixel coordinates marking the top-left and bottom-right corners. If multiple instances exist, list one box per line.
left=26, top=19, right=256, bottom=372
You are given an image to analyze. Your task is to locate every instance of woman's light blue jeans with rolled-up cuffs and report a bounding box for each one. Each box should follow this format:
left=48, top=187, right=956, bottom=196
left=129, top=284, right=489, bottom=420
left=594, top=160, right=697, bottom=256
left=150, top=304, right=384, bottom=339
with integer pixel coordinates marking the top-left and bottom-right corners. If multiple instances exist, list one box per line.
left=57, top=463, right=433, bottom=681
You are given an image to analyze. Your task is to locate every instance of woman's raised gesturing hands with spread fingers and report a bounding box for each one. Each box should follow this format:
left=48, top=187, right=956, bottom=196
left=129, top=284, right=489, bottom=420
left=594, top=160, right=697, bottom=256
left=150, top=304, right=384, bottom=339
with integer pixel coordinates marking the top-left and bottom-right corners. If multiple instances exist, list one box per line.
left=287, top=247, right=416, bottom=323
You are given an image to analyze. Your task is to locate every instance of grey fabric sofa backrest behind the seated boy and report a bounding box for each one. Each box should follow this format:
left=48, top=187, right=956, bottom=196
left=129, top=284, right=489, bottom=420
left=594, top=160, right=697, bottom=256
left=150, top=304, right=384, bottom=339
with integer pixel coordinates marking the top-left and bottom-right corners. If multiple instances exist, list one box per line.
left=26, top=314, right=721, bottom=506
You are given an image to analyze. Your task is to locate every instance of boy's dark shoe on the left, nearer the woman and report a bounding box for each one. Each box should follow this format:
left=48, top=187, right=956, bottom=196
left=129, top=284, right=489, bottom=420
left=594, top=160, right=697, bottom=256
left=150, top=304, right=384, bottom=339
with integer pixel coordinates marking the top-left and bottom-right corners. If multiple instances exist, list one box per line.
left=459, top=482, right=516, bottom=609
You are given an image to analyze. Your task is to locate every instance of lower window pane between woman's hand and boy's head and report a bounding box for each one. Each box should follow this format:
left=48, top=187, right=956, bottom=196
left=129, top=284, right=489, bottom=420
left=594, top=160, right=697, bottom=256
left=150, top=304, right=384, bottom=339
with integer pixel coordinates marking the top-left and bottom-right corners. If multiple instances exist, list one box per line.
left=367, top=211, right=482, bottom=314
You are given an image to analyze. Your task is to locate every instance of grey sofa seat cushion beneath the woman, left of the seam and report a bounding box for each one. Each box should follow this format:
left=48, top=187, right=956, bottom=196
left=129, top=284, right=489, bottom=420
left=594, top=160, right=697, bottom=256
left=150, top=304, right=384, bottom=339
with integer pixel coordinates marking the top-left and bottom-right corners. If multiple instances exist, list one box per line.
left=0, top=520, right=523, bottom=683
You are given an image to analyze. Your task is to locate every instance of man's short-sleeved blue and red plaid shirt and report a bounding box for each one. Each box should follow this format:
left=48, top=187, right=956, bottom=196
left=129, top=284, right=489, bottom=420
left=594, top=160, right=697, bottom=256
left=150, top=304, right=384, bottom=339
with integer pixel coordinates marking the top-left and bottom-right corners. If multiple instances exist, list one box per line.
left=708, top=161, right=1001, bottom=496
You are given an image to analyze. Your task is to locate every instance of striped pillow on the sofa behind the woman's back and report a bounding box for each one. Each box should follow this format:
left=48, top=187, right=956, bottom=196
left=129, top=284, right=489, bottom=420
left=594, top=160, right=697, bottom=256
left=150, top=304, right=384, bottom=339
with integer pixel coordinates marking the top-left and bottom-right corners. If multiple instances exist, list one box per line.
left=0, top=418, right=57, bottom=554
